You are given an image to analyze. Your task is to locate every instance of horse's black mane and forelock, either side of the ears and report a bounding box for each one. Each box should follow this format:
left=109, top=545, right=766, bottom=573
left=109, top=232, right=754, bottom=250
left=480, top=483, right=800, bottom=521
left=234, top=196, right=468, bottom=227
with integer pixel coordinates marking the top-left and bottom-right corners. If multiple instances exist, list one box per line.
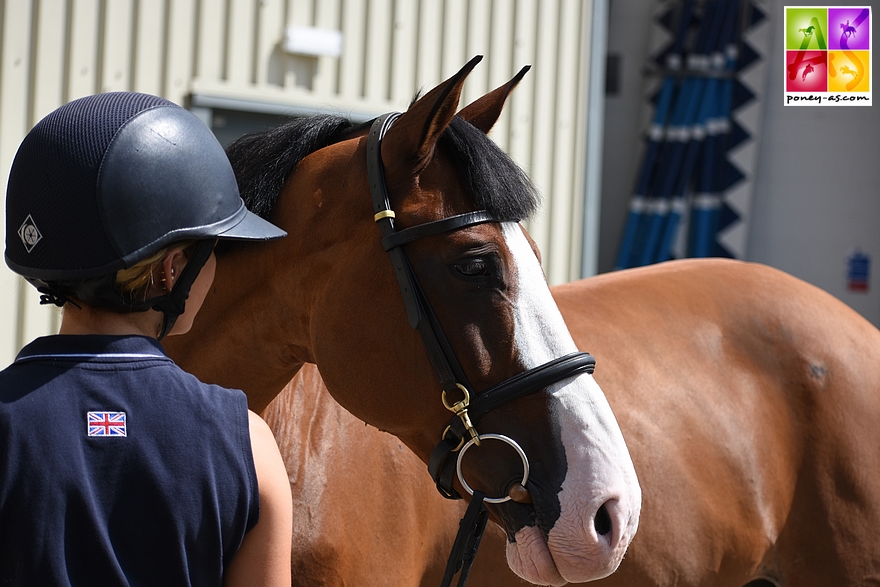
left=220, top=110, right=540, bottom=239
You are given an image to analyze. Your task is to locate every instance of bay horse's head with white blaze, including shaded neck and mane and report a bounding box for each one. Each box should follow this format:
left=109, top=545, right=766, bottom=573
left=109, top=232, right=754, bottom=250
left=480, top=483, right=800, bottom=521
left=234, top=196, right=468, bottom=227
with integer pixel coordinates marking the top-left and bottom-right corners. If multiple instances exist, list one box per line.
left=177, top=59, right=641, bottom=585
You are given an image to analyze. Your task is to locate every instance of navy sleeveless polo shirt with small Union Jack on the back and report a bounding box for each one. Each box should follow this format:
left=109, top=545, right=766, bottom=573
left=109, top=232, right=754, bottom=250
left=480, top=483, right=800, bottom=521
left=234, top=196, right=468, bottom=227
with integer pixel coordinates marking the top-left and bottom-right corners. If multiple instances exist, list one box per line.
left=0, top=335, right=259, bottom=586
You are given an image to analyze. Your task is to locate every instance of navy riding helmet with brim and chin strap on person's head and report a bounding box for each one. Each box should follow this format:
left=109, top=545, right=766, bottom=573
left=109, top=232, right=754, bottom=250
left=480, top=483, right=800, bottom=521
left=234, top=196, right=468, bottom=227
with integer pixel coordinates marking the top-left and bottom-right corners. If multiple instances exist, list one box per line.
left=5, top=92, right=286, bottom=338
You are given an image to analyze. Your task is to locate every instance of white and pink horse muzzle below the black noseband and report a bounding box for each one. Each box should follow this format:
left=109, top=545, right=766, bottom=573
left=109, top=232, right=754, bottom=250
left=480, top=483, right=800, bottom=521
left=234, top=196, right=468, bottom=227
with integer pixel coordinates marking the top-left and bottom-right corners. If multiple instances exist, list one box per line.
left=507, top=377, right=641, bottom=585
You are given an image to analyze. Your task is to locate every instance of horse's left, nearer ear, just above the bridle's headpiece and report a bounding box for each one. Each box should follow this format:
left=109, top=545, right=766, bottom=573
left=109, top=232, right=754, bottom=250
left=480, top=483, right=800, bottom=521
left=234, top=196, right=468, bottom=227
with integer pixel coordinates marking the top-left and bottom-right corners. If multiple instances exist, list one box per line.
left=382, top=55, right=483, bottom=164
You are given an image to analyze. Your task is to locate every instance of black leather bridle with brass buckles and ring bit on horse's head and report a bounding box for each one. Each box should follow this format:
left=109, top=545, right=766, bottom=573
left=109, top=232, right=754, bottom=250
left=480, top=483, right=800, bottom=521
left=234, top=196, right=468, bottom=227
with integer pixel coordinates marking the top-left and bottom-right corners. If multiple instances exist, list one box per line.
left=367, top=112, right=596, bottom=587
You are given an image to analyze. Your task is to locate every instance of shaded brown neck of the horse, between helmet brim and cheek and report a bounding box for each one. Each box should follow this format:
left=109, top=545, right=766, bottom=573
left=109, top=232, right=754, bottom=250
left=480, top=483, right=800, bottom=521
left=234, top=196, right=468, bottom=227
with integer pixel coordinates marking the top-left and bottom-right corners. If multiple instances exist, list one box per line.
left=167, top=141, right=381, bottom=412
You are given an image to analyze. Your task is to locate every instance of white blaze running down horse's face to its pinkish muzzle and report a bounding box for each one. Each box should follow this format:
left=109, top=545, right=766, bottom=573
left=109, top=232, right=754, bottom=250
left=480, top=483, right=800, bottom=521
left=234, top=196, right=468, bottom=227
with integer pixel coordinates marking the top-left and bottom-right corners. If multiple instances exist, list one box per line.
left=502, top=223, right=641, bottom=585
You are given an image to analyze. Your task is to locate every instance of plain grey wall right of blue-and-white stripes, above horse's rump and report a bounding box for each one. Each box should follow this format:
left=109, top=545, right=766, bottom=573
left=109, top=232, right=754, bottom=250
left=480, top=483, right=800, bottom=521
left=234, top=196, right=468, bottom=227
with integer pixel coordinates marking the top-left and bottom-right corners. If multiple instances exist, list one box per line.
left=748, top=0, right=880, bottom=325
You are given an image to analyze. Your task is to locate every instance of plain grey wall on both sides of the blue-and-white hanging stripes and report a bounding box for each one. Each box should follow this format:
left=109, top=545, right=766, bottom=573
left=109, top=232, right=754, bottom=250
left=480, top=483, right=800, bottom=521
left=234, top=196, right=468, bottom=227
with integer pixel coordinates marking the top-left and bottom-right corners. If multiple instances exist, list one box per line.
left=599, top=0, right=880, bottom=325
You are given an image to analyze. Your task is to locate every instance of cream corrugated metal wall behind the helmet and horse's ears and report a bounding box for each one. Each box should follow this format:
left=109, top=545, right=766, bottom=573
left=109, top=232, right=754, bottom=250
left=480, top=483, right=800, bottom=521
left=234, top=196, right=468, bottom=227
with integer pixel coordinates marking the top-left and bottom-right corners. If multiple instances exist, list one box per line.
left=0, top=0, right=593, bottom=364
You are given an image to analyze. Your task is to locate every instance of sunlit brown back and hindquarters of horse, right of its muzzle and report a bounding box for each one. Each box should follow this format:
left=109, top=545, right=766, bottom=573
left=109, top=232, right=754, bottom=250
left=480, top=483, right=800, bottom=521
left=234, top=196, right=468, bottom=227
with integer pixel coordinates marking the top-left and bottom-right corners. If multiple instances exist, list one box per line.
left=553, top=260, right=880, bottom=587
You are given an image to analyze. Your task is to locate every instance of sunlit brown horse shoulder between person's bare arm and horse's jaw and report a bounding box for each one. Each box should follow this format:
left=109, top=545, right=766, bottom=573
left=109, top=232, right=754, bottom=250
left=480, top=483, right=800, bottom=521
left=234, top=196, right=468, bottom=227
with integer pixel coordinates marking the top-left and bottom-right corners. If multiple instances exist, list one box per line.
left=262, top=363, right=516, bottom=587
